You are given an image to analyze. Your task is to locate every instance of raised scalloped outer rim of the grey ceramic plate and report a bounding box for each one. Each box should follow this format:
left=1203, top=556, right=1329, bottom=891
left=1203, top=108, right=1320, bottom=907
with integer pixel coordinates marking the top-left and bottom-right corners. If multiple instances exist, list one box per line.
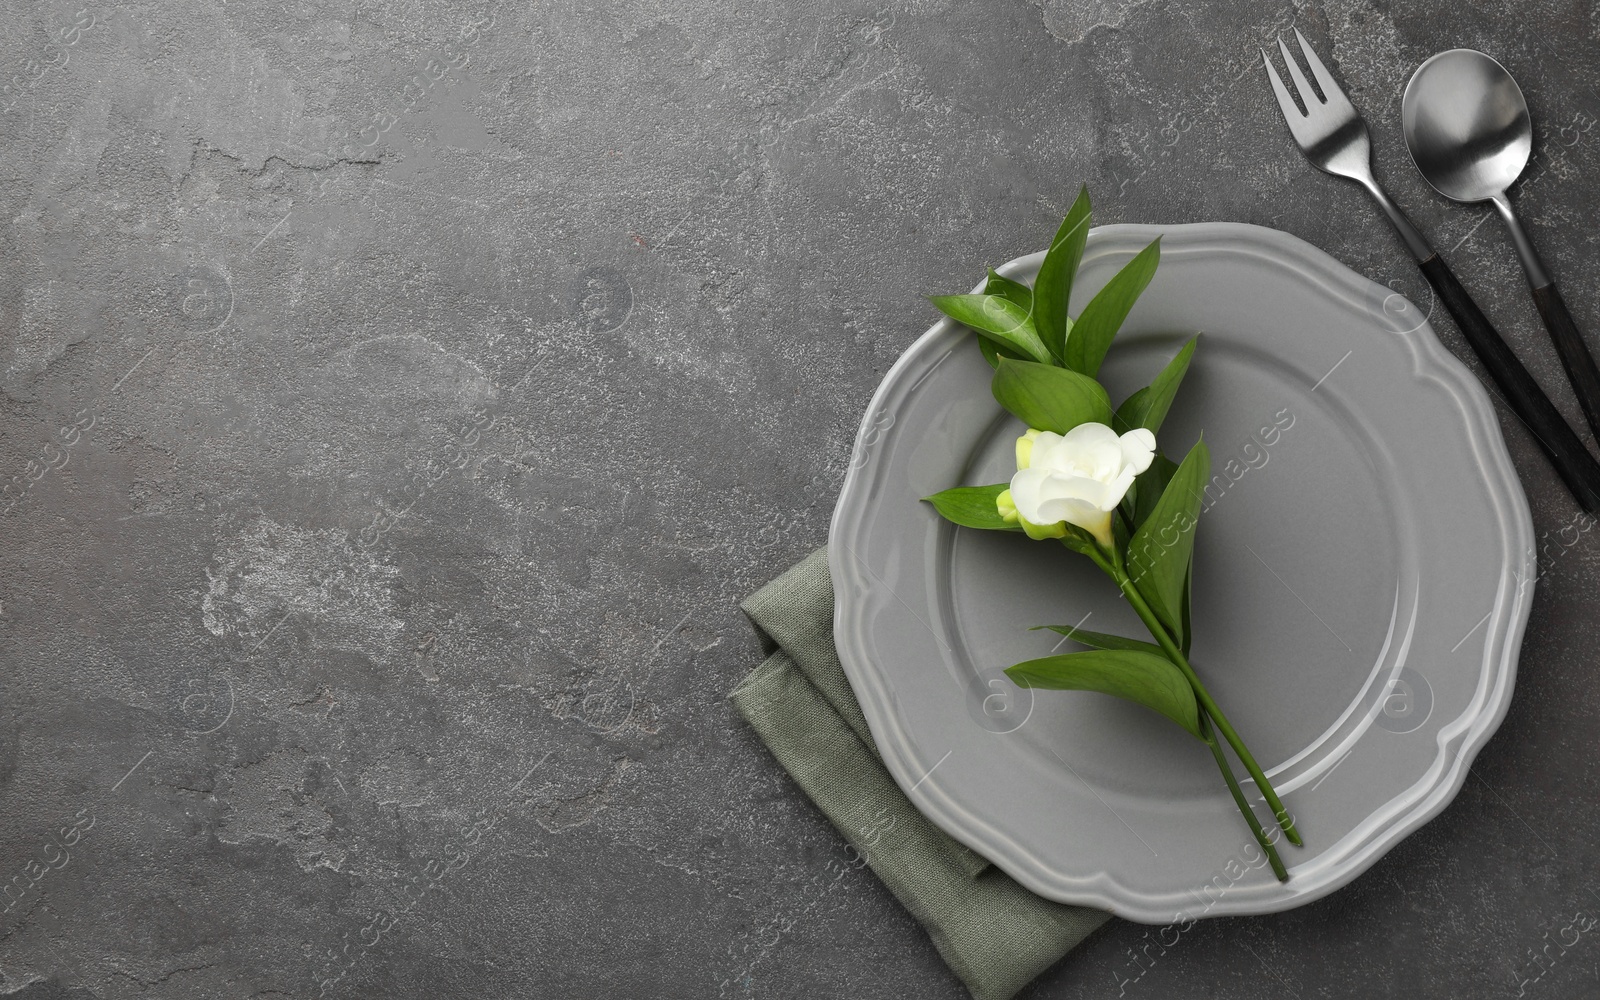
left=827, top=222, right=1536, bottom=923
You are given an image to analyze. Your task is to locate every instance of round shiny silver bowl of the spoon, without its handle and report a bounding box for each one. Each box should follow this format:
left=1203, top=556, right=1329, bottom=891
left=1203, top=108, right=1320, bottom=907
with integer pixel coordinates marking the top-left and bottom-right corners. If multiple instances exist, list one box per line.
left=1400, top=48, right=1533, bottom=202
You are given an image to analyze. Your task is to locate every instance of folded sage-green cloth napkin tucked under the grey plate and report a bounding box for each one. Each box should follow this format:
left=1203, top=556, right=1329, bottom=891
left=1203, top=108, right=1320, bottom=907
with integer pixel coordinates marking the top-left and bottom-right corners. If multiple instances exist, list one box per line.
left=730, top=549, right=1110, bottom=1000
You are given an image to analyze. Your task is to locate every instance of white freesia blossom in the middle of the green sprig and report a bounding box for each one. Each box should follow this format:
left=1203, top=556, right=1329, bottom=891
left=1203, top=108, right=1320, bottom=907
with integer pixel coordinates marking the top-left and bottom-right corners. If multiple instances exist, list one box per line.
left=998, top=424, right=1155, bottom=547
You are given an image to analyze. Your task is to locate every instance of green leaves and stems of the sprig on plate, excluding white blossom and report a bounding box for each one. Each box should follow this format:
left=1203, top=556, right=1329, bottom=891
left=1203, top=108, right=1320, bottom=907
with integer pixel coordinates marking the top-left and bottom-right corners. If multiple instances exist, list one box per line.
left=925, top=189, right=1302, bottom=880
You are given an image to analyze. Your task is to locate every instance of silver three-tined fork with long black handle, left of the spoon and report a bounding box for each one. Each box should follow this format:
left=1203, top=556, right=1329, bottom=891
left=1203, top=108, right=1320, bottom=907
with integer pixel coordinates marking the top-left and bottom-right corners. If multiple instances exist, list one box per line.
left=1261, top=27, right=1600, bottom=514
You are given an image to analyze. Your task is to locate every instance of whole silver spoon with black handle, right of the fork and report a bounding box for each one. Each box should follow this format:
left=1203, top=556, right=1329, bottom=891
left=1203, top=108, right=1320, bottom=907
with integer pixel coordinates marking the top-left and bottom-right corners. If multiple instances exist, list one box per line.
left=1400, top=48, right=1600, bottom=437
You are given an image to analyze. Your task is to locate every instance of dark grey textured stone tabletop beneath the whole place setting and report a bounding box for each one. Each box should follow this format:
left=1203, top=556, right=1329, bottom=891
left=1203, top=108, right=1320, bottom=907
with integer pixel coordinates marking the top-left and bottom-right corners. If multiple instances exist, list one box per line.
left=0, top=0, right=1600, bottom=1000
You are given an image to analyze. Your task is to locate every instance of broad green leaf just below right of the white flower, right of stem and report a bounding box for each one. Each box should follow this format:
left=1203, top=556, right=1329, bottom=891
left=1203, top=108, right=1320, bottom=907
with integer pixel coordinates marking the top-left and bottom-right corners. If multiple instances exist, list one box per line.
left=1126, top=440, right=1211, bottom=645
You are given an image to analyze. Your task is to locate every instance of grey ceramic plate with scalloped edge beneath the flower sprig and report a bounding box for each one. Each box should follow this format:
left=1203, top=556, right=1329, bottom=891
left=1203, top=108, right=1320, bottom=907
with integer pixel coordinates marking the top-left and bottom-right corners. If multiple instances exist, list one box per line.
left=829, top=224, right=1534, bottom=923
